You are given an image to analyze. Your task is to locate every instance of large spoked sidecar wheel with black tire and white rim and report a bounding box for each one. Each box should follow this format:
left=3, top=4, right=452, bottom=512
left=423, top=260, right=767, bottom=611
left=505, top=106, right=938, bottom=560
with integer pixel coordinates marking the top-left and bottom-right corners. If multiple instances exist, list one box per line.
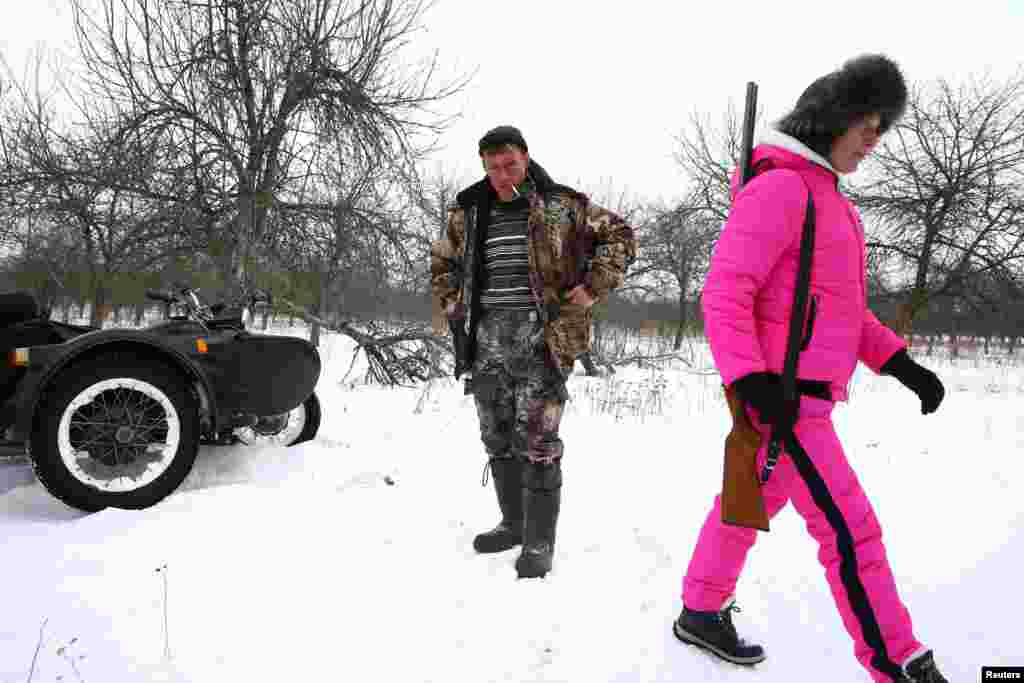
left=30, top=354, right=200, bottom=512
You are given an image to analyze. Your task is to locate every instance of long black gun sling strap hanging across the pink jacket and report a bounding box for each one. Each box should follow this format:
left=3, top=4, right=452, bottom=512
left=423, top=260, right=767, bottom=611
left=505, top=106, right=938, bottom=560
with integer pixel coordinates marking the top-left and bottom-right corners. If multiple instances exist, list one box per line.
left=761, top=180, right=815, bottom=483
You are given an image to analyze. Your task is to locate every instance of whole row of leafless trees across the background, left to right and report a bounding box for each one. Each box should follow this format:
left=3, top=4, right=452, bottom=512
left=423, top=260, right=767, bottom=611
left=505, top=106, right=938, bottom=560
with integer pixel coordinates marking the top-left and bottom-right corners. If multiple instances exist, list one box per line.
left=0, top=0, right=1024, bottom=362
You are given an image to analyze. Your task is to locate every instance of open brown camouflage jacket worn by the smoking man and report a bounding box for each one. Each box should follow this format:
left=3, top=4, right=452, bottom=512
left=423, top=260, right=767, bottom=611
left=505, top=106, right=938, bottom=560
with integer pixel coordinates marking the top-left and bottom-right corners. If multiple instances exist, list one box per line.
left=430, top=160, right=637, bottom=372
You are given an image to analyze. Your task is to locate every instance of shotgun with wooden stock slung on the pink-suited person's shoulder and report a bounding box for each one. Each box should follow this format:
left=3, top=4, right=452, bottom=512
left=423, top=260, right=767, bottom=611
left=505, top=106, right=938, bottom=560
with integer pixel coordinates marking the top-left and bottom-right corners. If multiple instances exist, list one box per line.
left=721, top=82, right=768, bottom=531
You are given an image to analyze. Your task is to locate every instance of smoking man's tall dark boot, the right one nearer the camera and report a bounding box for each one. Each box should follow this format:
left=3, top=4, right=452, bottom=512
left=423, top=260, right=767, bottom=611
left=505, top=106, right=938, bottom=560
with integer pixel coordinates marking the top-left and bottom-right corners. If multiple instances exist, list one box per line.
left=515, top=462, right=562, bottom=579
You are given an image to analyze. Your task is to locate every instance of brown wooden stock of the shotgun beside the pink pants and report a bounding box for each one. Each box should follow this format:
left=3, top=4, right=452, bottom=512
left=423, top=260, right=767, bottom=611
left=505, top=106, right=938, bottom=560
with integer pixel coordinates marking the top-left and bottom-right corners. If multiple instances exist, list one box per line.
left=721, top=387, right=768, bottom=531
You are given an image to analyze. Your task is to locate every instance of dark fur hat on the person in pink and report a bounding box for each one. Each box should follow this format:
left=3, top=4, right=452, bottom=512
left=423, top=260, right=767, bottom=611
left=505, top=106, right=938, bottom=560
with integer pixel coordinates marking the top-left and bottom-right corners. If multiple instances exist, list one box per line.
left=776, top=54, right=907, bottom=159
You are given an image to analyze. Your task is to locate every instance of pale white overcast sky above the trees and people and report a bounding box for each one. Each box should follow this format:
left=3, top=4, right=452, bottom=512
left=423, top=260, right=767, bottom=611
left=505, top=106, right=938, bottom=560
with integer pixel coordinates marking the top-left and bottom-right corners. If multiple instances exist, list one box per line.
left=0, top=0, right=1024, bottom=206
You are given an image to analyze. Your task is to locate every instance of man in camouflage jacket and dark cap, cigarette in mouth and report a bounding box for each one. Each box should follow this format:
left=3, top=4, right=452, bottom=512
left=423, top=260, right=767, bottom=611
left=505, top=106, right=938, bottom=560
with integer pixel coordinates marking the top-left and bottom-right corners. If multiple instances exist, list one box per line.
left=430, top=126, right=636, bottom=578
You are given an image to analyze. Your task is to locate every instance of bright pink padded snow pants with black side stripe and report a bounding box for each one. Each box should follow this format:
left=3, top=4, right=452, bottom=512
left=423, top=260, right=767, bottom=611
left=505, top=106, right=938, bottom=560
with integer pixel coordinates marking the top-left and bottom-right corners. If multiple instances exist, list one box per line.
left=682, top=396, right=922, bottom=682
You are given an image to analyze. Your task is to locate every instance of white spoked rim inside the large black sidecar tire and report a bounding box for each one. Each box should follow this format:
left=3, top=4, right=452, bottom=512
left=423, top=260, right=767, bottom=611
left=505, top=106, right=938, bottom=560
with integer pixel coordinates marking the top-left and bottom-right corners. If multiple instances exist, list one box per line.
left=57, top=377, right=181, bottom=493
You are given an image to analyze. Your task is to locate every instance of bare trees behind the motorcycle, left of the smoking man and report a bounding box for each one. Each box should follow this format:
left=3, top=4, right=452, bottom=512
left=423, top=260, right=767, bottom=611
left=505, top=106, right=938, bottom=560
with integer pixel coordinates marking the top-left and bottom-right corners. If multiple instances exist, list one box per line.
left=0, top=0, right=465, bottom=339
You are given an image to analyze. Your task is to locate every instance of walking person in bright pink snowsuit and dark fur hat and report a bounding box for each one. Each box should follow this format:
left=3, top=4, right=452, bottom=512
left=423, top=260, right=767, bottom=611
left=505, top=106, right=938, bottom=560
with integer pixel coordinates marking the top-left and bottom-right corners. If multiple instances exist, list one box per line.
left=673, top=55, right=946, bottom=683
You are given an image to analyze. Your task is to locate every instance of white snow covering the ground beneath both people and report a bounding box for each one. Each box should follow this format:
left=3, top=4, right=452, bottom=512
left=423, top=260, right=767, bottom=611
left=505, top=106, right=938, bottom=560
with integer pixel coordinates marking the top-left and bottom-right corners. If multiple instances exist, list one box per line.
left=0, top=328, right=1024, bottom=683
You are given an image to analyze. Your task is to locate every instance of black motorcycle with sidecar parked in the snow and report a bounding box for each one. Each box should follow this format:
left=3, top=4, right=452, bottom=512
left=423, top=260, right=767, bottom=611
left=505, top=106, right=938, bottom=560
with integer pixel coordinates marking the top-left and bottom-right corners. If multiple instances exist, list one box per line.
left=0, top=293, right=321, bottom=511
